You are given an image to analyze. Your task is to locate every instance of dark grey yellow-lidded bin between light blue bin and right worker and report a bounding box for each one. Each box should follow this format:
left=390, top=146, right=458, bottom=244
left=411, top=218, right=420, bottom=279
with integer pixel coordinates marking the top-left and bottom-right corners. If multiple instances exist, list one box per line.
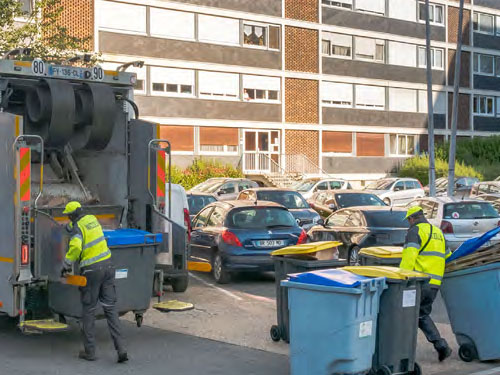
left=342, top=266, right=429, bottom=375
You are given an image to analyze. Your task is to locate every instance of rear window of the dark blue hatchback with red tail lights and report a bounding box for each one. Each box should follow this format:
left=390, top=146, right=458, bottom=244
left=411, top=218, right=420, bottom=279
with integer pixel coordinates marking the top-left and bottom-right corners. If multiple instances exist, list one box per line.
left=227, top=207, right=297, bottom=229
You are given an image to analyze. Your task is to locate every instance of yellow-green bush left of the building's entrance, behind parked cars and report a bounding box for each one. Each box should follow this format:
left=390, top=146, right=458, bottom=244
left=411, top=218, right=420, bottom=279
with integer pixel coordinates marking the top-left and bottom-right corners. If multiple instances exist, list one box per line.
left=172, top=158, right=244, bottom=190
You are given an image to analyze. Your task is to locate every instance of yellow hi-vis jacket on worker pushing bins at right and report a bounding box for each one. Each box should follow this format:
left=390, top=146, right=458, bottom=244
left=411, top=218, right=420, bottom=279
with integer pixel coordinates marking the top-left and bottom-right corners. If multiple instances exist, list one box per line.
left=400, top=219, right=451, bottom=287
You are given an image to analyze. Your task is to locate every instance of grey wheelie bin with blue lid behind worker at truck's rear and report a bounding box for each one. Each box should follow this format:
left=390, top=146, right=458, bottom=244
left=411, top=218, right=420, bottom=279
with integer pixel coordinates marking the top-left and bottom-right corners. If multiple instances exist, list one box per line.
left=48, top=229, right=162, bottom=326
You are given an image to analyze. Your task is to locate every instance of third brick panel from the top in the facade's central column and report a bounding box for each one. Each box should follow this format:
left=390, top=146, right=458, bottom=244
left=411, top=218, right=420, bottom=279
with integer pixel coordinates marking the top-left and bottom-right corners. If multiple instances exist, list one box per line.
left=285, top=78, right=319, bottom=124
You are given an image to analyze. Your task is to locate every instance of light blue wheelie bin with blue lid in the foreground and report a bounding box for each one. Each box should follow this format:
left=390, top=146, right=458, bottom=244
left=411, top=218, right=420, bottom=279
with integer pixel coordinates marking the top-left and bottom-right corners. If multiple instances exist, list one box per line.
left=282, top=269, right=385, bottom=375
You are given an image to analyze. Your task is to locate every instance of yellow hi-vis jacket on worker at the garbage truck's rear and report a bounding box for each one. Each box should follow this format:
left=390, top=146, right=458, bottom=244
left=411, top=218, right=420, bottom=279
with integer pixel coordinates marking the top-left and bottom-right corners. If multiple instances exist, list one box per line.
left=65, top=215, right=111, bottom=267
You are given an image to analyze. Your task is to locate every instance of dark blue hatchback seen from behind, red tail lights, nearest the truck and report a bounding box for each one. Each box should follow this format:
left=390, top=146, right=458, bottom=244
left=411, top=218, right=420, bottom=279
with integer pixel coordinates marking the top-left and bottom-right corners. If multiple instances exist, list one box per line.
left=191, top=200, right=307, bottom=284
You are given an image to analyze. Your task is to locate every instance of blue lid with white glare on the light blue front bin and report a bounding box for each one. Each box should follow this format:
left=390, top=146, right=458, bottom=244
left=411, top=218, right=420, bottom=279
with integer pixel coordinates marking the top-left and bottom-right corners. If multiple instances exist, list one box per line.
left=289, top=269, right=370, bottom=288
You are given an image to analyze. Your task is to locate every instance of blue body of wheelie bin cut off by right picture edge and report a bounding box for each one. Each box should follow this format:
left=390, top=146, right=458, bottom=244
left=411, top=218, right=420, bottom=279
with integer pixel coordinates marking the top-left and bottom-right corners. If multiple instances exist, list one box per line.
left=441, top=263, right=500, bottom=362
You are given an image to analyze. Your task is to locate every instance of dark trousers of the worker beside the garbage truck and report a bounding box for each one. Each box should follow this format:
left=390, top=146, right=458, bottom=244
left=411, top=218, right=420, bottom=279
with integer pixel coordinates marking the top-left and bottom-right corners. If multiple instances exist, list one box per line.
left=80, top=260, right=126, bottom=355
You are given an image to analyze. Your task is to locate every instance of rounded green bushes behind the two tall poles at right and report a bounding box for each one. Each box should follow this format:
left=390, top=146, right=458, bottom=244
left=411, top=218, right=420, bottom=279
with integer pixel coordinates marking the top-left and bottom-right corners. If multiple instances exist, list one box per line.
left=399, top=155, right=483, bottom=185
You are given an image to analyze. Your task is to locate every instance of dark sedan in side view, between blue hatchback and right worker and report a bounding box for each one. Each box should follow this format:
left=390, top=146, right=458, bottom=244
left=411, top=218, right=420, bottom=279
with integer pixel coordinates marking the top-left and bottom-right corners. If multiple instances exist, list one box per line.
left=308, top=206, right=408, bottom=264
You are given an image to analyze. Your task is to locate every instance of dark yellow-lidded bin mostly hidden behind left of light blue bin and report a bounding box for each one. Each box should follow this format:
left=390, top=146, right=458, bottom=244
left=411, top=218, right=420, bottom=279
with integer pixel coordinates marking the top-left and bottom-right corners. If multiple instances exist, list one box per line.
left=270, top=241, right=347, bottom=342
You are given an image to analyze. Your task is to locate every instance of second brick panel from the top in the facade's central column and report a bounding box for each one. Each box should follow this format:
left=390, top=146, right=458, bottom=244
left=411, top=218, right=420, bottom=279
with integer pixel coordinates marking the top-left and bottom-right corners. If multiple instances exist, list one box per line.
left=285, top=26, right=319, bottom=73
